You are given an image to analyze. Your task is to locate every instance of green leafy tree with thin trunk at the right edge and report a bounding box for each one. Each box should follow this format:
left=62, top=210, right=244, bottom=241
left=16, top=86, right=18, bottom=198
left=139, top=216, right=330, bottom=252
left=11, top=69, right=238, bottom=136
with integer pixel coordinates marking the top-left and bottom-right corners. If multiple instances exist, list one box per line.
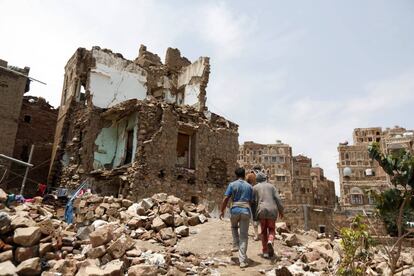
left=368, top=142, right=414, bottom=275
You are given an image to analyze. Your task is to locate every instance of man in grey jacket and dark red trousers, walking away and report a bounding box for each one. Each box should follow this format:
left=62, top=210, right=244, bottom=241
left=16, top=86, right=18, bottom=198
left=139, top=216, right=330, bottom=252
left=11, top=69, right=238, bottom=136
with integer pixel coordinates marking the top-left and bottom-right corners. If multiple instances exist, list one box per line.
left=252, top=172, right=283, bottom=258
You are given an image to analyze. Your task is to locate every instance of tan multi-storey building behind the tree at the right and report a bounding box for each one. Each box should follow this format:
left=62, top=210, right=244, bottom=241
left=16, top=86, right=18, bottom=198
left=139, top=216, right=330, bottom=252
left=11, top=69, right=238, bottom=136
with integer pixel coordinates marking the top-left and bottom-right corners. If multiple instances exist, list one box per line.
left=337, top=126, right=414, bottom=213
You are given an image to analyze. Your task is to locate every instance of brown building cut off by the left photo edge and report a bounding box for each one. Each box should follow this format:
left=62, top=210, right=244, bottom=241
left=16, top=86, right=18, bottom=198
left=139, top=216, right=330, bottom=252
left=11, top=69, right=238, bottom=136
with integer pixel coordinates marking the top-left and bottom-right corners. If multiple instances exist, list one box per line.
left=0, top=59, right=30, bottom=172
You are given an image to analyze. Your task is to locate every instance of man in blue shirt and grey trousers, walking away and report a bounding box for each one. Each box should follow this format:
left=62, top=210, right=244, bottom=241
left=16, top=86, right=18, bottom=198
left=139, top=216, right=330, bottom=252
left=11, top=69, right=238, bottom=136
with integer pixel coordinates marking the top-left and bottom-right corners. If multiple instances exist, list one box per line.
left=220, top=168, right=253, bottom=268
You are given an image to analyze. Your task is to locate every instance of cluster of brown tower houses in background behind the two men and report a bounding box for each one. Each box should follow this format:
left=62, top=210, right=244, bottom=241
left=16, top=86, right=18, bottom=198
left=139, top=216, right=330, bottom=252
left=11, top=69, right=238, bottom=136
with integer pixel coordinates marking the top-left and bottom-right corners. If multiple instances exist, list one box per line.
left=238, top=141, right=335, bottom=207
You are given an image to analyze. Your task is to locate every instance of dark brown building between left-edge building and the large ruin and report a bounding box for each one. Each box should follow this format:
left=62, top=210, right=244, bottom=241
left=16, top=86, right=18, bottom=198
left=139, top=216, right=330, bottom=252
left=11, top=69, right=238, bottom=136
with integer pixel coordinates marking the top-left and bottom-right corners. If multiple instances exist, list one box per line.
left=5, top=96, right=58, bottom=196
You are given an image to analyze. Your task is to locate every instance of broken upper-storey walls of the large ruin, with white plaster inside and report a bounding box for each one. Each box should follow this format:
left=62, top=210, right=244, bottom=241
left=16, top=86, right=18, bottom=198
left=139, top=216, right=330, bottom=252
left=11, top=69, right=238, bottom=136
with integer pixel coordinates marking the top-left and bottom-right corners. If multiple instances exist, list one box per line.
left=49, top=45, right=210, bottom=187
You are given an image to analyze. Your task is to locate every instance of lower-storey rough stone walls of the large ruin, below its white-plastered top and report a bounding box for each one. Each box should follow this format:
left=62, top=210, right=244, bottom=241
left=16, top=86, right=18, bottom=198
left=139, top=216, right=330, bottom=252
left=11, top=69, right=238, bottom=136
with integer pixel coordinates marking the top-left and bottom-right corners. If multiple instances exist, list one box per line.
left=54, top=100, right=238, bottom=209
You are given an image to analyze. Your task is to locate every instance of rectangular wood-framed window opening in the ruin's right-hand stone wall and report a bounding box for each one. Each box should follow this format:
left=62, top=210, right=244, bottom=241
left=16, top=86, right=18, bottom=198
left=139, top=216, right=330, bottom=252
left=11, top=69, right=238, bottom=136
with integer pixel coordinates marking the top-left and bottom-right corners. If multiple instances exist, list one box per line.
left=176, top=132, right=196, bottom=169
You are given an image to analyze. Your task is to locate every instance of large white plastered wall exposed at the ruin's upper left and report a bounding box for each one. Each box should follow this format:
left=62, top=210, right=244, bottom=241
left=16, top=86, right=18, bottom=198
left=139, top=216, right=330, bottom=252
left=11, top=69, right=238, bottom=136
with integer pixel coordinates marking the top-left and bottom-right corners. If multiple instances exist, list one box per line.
left=87, top=49, right=147, bottom=108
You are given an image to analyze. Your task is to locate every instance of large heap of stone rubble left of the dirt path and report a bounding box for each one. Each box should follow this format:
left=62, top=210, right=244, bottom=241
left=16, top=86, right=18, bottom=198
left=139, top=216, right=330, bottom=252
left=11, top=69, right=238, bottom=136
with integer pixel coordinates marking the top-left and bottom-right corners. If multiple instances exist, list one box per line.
left=0, top=191, right=217, bottom=276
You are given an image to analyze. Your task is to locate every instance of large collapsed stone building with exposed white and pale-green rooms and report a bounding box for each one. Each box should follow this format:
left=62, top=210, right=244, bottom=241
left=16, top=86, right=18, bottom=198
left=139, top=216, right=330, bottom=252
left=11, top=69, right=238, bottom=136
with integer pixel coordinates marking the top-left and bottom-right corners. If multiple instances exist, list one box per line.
left=49, top=46, right=238, bottom=203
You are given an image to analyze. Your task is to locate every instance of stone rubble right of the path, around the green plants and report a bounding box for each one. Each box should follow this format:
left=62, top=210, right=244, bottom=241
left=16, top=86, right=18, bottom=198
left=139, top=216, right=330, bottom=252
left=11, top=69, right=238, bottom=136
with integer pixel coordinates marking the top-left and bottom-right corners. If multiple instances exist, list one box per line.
left=262, top=223, right=414, bottom=276
